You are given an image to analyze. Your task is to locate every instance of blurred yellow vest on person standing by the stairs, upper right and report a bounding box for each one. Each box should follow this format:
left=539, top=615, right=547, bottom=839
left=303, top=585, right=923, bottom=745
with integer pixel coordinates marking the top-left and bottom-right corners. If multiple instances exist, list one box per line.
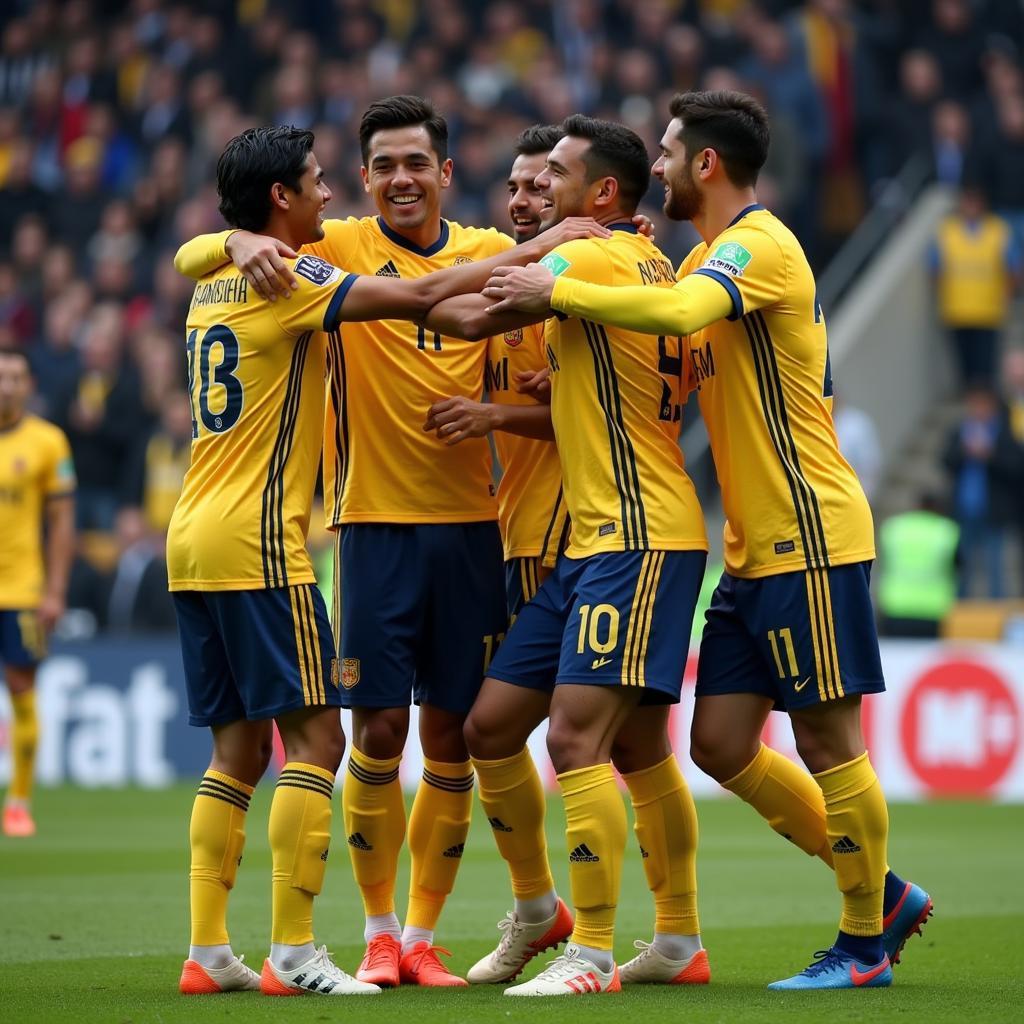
left=936, top=214, right=1010, bottom=328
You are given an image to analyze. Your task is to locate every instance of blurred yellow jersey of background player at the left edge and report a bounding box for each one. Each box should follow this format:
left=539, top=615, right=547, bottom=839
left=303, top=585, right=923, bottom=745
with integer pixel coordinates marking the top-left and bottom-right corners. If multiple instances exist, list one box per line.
left=0, top=414, right=75, bottom=610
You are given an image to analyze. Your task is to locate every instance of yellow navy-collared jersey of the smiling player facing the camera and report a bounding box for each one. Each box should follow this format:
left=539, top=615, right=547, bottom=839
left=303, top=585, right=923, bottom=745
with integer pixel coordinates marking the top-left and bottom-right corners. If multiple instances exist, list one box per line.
left=311, top=217, right=515, bottom=527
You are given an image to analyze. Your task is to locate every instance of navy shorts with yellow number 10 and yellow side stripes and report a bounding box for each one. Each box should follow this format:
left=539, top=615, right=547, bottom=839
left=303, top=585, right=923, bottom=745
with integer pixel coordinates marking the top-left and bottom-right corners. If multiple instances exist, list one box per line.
left=487, top=551, right=708, bottom=703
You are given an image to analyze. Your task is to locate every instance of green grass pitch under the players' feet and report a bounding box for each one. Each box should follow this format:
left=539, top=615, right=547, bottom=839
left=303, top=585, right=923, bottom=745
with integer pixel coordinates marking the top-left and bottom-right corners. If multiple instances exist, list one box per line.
left=0, top=785, right=1024, bottom=1024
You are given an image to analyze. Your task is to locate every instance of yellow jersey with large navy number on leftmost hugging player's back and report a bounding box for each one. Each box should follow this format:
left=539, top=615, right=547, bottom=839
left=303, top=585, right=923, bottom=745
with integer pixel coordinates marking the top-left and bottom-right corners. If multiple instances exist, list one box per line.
left=167, top=255, right=355, bottom=591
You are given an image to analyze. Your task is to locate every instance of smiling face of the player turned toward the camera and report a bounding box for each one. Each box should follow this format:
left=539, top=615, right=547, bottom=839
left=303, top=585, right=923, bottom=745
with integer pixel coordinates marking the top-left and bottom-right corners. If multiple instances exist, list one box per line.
left=362, top=125, right=452, bottom=232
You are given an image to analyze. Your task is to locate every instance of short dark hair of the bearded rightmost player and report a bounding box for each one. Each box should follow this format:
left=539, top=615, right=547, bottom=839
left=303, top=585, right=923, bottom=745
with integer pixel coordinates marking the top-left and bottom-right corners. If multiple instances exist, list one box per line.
left=669, top=90, right=771, bottom=188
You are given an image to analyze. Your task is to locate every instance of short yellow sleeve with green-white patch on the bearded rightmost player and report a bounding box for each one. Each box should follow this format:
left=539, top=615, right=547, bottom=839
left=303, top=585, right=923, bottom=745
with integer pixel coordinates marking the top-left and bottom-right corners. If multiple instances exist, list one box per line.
left=693, top=223, right=788, bottom=319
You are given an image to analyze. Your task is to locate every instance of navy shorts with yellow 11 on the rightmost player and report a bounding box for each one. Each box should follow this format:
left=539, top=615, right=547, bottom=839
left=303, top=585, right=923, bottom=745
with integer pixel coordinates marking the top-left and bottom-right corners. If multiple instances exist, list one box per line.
left=696, top=562, right=886, bottom=711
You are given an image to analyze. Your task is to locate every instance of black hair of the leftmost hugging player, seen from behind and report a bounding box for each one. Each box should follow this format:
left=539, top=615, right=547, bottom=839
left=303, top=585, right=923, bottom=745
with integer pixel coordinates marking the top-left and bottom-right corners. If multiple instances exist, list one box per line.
left=217, top=125, right=313, bottom=231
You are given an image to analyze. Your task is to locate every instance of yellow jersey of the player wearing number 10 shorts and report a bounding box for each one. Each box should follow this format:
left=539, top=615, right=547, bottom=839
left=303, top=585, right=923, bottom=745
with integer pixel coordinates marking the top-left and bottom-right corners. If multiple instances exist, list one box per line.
left=542, top=224, right=708, bottom=558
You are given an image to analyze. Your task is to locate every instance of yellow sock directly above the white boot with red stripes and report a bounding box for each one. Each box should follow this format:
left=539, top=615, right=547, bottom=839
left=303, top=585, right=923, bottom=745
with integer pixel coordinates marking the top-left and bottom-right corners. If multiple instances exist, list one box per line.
left=558, top=764, right=626, bottom=949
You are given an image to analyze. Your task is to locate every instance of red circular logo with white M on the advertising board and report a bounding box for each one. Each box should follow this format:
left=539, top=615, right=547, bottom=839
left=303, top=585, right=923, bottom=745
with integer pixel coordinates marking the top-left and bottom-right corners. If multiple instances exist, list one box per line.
left=900, top=660, right=1021, bottom=797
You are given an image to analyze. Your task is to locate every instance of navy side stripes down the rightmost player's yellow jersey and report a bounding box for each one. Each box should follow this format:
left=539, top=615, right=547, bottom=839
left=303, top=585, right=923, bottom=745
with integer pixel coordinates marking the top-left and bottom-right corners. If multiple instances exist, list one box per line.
left=743, top=311, right=828, bottom=568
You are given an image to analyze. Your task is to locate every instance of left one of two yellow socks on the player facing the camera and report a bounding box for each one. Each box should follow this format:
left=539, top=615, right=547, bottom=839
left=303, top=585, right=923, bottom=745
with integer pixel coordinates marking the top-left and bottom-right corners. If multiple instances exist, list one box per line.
left=341, top=746, right=406, bottom=918
